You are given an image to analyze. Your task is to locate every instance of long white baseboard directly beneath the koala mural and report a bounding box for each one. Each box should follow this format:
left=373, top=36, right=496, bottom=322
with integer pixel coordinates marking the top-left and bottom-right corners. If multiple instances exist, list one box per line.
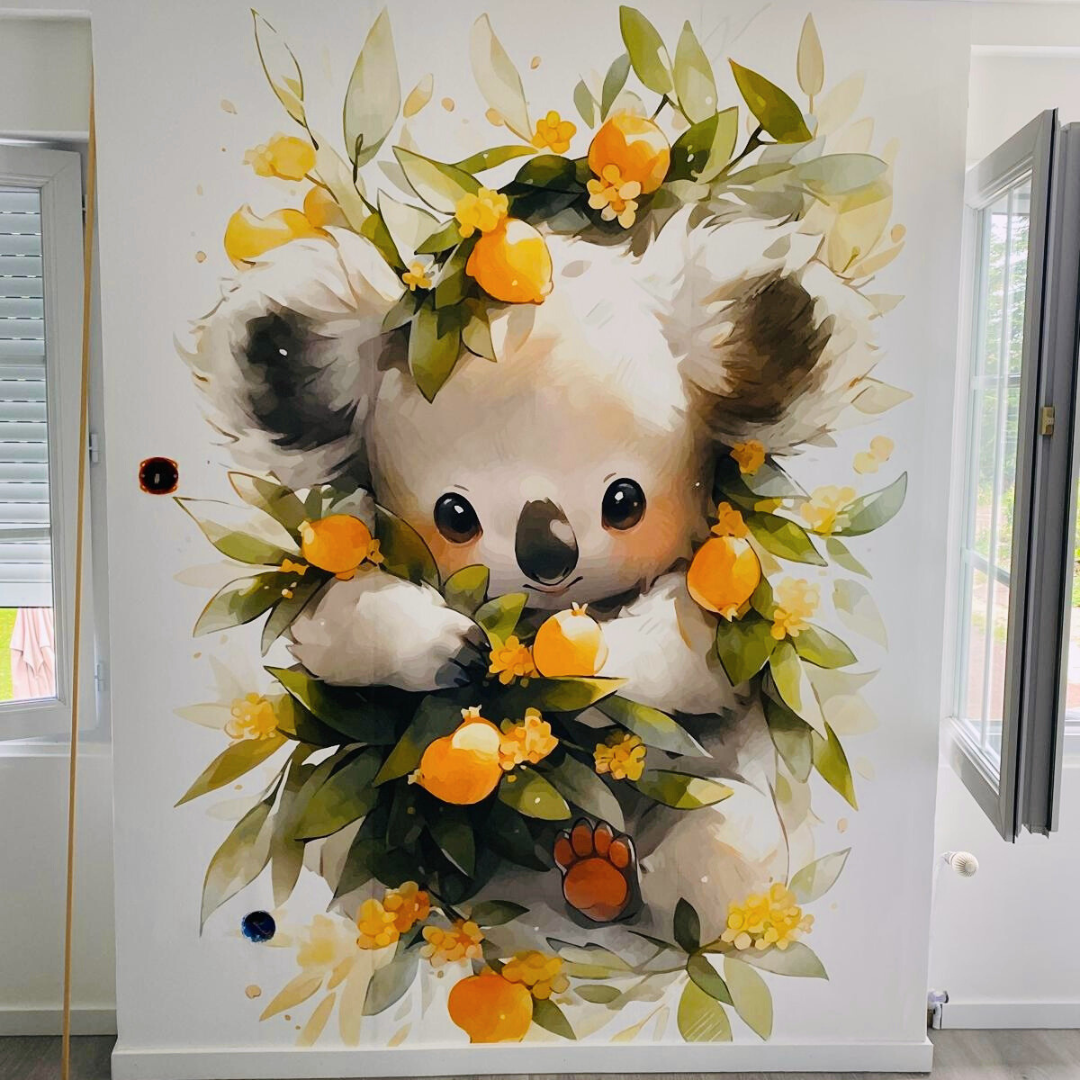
left=112, top=1039, right=933, bottom=1080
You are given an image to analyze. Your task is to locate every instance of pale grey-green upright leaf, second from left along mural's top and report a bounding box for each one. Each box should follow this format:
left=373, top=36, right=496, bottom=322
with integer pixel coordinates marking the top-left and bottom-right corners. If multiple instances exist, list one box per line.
left=342, top=8, right=402, bottom=168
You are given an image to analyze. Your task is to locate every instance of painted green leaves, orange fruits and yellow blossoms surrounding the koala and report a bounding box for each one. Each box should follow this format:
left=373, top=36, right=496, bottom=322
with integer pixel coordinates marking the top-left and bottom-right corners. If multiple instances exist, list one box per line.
left=177, top=6, right=907, bottom=1043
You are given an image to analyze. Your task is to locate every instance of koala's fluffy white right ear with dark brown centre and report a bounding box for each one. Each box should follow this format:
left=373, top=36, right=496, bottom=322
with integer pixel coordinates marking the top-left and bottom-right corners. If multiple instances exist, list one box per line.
left=669, top=220, right=878, bottom=454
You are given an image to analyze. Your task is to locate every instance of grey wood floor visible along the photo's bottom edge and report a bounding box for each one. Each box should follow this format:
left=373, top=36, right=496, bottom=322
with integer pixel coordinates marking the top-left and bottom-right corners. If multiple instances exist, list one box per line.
left=0, top=1031, right=1080, bottom=1080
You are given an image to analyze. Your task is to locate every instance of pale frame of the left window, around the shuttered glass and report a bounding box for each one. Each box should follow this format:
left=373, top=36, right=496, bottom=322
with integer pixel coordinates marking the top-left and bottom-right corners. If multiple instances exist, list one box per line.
left=0, top=145, right=83, bottom=740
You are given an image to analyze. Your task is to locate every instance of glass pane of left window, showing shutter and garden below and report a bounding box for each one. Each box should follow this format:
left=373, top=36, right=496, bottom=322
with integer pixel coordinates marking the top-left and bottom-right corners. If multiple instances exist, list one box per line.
left=0, top=188, right=56, bottom=702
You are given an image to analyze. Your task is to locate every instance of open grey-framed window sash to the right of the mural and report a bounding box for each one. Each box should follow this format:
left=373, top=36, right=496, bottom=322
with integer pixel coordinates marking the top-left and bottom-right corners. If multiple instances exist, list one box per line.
left=950, top=111, right=1080, bottom=840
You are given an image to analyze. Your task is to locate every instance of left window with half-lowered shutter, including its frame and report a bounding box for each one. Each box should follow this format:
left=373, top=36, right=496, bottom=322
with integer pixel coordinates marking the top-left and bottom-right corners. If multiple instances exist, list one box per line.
left=0, top=146, right=82, bottom=738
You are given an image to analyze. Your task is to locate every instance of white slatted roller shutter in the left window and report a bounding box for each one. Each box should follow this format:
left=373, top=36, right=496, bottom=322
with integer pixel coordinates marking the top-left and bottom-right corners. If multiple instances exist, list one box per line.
left=0, top=188, right=53, bottom=608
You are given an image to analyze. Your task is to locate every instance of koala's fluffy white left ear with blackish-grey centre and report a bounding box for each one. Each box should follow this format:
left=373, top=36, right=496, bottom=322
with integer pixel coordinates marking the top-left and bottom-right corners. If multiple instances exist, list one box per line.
left=187, top=229, right=402, bottom=488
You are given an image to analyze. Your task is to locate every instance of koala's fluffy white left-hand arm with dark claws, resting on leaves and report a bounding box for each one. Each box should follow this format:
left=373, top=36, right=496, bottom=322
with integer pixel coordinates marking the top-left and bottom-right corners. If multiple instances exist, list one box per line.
left=289, top=568, right=480, bottom=690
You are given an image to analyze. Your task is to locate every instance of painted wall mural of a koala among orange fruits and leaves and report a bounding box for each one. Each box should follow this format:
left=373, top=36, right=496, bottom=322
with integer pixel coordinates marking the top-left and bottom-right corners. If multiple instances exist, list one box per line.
left=177, top=6, right=908, bottom=1045
